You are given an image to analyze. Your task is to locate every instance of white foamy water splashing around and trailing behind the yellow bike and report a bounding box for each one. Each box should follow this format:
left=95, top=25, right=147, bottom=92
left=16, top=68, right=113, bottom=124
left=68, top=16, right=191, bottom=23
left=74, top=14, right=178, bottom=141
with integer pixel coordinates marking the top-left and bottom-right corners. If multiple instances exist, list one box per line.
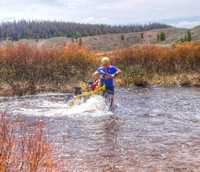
left=0, top=96, right=111, bottom=117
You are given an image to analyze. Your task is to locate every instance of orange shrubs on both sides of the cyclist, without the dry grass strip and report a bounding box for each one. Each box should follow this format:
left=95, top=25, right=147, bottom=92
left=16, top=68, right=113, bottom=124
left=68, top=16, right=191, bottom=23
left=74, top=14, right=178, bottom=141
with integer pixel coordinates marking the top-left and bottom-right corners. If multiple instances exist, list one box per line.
left=0, top=42, right=200, bottom=94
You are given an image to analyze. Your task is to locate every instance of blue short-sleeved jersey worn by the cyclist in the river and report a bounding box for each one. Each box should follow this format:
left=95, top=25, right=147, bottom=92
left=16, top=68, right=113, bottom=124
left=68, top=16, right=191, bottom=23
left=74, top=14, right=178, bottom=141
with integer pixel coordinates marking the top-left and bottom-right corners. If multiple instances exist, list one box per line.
left=97, top=65, right=117, bottom=87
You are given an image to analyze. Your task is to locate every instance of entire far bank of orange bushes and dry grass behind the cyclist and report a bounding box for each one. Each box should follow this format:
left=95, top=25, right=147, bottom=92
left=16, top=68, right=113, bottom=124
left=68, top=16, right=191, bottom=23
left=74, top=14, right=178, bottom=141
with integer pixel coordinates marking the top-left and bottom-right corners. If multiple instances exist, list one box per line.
left=0, top=42, right=200, bottom=95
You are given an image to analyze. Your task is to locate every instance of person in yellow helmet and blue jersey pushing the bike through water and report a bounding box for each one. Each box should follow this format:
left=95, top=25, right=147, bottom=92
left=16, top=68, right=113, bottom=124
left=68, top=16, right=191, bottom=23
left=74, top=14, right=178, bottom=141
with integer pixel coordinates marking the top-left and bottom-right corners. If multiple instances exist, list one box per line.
left=92, top=57, right=122, bottom=97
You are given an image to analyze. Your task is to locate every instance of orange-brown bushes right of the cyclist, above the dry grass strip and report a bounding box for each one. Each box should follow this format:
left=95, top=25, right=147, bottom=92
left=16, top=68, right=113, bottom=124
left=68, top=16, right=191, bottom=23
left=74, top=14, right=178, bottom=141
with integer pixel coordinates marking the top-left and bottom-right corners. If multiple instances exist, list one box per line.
left=112, top=42, right=200, bottom=85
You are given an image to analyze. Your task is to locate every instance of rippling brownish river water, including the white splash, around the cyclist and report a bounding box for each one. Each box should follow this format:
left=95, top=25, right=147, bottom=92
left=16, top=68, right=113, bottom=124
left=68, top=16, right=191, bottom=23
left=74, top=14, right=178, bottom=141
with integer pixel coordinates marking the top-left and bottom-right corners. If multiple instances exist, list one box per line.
left=0, top=86, right=200, bottom=172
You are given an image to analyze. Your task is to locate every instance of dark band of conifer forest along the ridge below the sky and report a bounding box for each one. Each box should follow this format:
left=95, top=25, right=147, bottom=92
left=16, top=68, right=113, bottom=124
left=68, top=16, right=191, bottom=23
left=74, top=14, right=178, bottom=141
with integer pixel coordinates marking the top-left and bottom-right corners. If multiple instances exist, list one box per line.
left=0, top=20, right=172, bottom=41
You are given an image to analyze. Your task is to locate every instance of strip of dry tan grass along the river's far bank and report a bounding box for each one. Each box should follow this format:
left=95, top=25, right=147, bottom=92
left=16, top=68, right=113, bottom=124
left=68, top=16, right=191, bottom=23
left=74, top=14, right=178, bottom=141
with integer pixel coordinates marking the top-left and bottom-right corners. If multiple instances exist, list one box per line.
left=0, top=73, right=200, bottom=96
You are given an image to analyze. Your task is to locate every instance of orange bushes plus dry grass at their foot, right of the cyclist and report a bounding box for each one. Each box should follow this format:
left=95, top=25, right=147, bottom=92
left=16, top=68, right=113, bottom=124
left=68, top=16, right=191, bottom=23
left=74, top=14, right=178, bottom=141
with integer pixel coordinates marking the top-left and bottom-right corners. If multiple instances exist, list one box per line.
left=112, top=42, right=200, bottom=86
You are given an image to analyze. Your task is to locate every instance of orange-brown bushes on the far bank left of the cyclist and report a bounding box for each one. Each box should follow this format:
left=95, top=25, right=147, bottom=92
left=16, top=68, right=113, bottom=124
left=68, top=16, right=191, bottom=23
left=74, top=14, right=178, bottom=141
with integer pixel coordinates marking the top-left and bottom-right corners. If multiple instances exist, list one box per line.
left=0, top=43, right=96, bottom=95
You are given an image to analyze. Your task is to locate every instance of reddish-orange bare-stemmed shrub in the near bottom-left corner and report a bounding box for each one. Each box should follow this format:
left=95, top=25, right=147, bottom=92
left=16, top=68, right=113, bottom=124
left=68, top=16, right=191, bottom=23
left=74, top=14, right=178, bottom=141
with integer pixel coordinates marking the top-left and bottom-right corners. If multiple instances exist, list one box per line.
left=0, top=111, right=66, bottom=172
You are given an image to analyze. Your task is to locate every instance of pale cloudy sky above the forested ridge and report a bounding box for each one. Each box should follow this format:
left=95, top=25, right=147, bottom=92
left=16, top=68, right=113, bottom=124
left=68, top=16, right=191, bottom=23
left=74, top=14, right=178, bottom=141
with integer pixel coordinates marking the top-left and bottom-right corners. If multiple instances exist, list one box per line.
left=0, top=0, right=200, bottom=28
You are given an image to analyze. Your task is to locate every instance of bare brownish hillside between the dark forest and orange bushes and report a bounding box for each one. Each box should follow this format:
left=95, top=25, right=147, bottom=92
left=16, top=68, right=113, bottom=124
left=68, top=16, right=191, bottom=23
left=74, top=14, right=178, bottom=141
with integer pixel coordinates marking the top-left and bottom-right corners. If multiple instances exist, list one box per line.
left=0, top=26, right=200, bottom=52
